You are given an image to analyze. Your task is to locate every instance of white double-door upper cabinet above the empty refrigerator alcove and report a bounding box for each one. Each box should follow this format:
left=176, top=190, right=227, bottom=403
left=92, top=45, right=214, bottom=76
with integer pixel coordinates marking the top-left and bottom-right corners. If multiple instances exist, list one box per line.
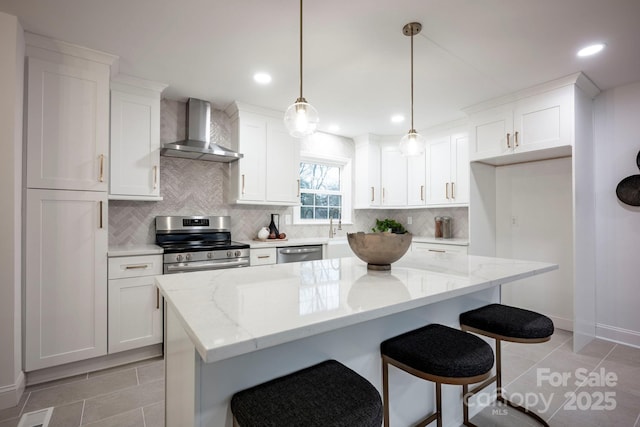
left=466, top=74, right=597, bottom=165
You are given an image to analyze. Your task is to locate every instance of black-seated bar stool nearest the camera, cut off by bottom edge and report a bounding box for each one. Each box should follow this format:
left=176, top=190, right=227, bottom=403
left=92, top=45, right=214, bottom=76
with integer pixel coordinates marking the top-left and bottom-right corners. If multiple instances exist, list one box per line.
left=231, top=360, right=382, bottom=427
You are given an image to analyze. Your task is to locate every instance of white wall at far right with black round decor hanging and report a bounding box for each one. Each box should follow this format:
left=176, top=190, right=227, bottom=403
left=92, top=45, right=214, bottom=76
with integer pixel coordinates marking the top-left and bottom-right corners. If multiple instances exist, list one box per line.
left=594, top=82, right=640, bottom=346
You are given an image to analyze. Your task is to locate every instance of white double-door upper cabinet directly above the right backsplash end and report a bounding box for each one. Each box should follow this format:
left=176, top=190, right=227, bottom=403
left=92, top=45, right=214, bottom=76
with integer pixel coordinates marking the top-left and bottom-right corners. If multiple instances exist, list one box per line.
left=427, top=133, right=469, bottom=206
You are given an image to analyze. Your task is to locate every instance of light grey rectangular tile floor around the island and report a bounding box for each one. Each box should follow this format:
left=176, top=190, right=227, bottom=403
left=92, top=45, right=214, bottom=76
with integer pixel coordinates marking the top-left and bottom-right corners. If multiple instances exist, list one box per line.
left=0, top=330, right=640, bottom=427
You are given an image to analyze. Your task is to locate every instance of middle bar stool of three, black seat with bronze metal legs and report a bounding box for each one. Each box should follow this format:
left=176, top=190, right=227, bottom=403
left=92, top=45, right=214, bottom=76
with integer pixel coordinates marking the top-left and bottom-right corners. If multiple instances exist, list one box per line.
left=380, top=324, right=493, bottom=427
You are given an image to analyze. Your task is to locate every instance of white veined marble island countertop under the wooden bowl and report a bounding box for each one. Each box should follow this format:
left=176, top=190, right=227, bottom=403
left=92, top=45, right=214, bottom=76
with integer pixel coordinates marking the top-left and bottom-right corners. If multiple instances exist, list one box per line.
left=155, top=253, right=558, bottom=363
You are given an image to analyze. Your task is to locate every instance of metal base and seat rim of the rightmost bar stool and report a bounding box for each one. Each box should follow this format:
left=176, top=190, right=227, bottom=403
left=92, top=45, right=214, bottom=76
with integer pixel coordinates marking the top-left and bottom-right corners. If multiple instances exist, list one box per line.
left=460, top=325, right=551, bottom=427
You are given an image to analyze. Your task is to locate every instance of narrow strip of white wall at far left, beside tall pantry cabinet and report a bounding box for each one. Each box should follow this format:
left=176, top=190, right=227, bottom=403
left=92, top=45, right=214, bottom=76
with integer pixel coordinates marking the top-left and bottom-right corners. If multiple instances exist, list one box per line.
left=0, top=12, right=24, bottom=409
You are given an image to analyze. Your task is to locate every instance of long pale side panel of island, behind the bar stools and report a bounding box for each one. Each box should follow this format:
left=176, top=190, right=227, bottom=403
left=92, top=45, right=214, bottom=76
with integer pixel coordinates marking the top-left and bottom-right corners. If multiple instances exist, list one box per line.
left=195, top=287, right=499, bottom=427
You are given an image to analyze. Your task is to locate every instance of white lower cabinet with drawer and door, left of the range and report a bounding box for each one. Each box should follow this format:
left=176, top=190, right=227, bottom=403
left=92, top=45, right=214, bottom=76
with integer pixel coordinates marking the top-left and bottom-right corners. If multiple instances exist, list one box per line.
left=108, top=255, right=162, bottom=354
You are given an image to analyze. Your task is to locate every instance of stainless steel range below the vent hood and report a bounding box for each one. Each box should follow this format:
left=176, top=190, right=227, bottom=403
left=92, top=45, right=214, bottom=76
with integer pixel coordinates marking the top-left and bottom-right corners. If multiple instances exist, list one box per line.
left=156, top=216, right=249, bottom=274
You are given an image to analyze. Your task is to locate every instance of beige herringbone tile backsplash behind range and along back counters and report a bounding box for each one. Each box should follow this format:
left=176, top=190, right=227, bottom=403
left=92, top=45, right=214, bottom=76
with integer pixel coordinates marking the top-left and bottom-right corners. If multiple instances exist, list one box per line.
left=109, top=100, right=469, bottom=246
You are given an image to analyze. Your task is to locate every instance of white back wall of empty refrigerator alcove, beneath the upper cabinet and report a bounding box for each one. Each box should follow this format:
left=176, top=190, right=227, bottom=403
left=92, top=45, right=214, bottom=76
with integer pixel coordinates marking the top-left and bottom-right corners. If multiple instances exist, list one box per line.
left=495, top=157, right=574, bottom=330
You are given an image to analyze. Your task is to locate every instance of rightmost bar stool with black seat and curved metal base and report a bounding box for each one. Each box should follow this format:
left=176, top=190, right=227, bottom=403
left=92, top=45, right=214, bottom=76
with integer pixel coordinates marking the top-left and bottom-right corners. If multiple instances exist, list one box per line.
left=460, top=304, right=553, bottom=427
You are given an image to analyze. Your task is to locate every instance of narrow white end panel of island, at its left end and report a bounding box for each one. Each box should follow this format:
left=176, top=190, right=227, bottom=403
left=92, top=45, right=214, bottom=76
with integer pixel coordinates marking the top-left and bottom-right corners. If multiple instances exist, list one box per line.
left=164, top=303, right=199, bottom=427
